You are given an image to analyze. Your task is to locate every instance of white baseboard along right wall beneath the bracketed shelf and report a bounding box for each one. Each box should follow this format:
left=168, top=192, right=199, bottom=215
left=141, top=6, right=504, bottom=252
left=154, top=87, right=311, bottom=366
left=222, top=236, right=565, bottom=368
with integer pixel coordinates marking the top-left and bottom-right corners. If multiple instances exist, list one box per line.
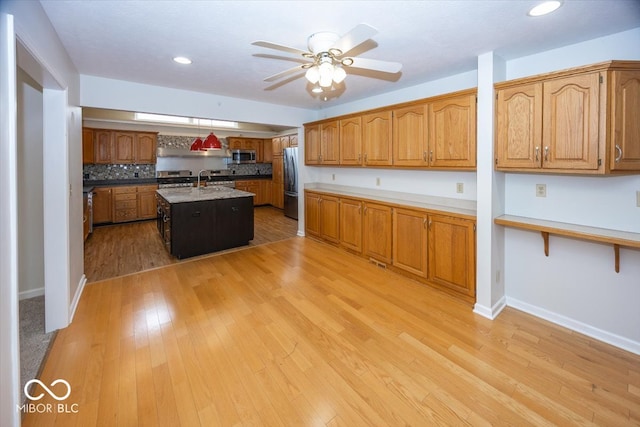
left=507, top=297, right=640, bottom=355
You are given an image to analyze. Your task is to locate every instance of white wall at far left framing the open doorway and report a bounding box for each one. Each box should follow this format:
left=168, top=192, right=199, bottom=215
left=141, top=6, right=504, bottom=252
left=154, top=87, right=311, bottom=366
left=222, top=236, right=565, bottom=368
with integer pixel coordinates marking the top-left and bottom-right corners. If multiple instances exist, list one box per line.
left=0, top=0, right=84, bottom=426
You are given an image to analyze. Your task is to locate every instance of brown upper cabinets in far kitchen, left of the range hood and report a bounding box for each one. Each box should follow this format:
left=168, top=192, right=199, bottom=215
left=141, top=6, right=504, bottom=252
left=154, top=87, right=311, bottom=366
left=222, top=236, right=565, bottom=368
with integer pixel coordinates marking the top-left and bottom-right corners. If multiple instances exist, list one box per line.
left=82, top=128, right=158, bottom=164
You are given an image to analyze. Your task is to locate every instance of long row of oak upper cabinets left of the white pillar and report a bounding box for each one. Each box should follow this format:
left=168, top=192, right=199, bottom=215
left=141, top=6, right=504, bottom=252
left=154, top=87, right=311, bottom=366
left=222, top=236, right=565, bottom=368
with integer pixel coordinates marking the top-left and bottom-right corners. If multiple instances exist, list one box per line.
left=305, top=89, right=476, bottom=170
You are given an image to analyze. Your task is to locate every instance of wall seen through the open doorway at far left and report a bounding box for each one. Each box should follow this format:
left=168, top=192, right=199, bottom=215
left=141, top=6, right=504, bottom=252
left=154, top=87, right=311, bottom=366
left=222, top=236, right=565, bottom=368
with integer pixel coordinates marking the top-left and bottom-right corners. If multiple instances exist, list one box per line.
left=17, top=69, right=44, bottom=299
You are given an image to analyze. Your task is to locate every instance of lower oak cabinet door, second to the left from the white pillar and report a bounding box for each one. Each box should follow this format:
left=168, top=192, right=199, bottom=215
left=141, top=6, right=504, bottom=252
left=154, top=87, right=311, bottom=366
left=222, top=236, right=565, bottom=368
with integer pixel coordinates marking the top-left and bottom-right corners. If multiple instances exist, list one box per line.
left=393, top=208, right=428, bottom=278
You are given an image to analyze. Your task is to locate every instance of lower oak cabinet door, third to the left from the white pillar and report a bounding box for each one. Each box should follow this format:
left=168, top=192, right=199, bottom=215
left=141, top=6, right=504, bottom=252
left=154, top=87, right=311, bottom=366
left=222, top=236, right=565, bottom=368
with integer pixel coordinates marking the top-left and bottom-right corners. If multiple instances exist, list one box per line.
left=363, top=203, right=392, bottom=263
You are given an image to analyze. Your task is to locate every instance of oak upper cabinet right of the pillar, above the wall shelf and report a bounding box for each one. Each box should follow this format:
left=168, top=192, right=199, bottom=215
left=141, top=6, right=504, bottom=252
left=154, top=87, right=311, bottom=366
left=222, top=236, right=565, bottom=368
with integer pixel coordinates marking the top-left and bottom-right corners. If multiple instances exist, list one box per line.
left=495, top=61, right=640, bottom=174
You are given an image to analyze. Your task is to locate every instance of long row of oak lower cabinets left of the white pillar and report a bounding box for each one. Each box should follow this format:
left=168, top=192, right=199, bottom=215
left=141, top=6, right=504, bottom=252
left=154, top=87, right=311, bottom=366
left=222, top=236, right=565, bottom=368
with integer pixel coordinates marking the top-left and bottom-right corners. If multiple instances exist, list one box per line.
left=305, top=190, right=476, bottom=302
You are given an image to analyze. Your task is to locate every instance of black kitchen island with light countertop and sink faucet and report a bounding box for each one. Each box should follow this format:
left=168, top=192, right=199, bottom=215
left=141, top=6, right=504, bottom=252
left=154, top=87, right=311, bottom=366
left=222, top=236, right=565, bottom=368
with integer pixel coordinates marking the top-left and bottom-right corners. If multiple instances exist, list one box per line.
left=156, top=186, right=254, bottom=259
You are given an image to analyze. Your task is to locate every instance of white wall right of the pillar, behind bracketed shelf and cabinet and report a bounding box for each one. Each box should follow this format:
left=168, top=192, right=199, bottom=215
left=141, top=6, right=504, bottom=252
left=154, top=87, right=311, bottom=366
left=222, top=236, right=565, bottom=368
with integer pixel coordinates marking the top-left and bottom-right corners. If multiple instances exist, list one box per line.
left=504, top=28, right=640, bottom=353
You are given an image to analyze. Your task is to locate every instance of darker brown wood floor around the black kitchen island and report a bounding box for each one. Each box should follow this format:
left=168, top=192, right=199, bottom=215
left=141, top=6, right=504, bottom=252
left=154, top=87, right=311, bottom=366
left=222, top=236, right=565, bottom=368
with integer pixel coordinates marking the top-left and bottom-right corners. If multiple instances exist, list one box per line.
left=84, top=206, right=298, bottom=282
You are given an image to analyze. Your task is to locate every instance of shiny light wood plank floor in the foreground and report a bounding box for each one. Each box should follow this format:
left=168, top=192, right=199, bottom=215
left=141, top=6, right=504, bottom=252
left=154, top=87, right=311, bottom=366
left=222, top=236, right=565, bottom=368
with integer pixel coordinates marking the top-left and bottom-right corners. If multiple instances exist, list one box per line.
left=23, top=237, right=640, bottom=427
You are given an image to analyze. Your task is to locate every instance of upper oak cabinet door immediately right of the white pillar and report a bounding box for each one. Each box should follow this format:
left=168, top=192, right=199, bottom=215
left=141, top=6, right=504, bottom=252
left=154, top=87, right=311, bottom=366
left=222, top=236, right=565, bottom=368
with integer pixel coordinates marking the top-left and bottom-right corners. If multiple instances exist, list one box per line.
left=495, top=83, right=542, bottom=169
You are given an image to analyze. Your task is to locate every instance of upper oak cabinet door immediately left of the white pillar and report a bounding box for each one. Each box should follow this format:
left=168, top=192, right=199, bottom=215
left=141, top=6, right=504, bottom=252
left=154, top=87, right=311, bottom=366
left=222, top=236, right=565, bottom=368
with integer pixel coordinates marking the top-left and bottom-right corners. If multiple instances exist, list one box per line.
left=429, top=94, right=476, bottom=169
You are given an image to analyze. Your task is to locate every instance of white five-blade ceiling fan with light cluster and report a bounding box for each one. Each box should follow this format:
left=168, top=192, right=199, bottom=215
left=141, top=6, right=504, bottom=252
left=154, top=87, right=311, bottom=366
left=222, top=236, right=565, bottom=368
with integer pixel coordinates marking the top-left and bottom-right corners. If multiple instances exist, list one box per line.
left=251, top=24, right=402, bottom=92
